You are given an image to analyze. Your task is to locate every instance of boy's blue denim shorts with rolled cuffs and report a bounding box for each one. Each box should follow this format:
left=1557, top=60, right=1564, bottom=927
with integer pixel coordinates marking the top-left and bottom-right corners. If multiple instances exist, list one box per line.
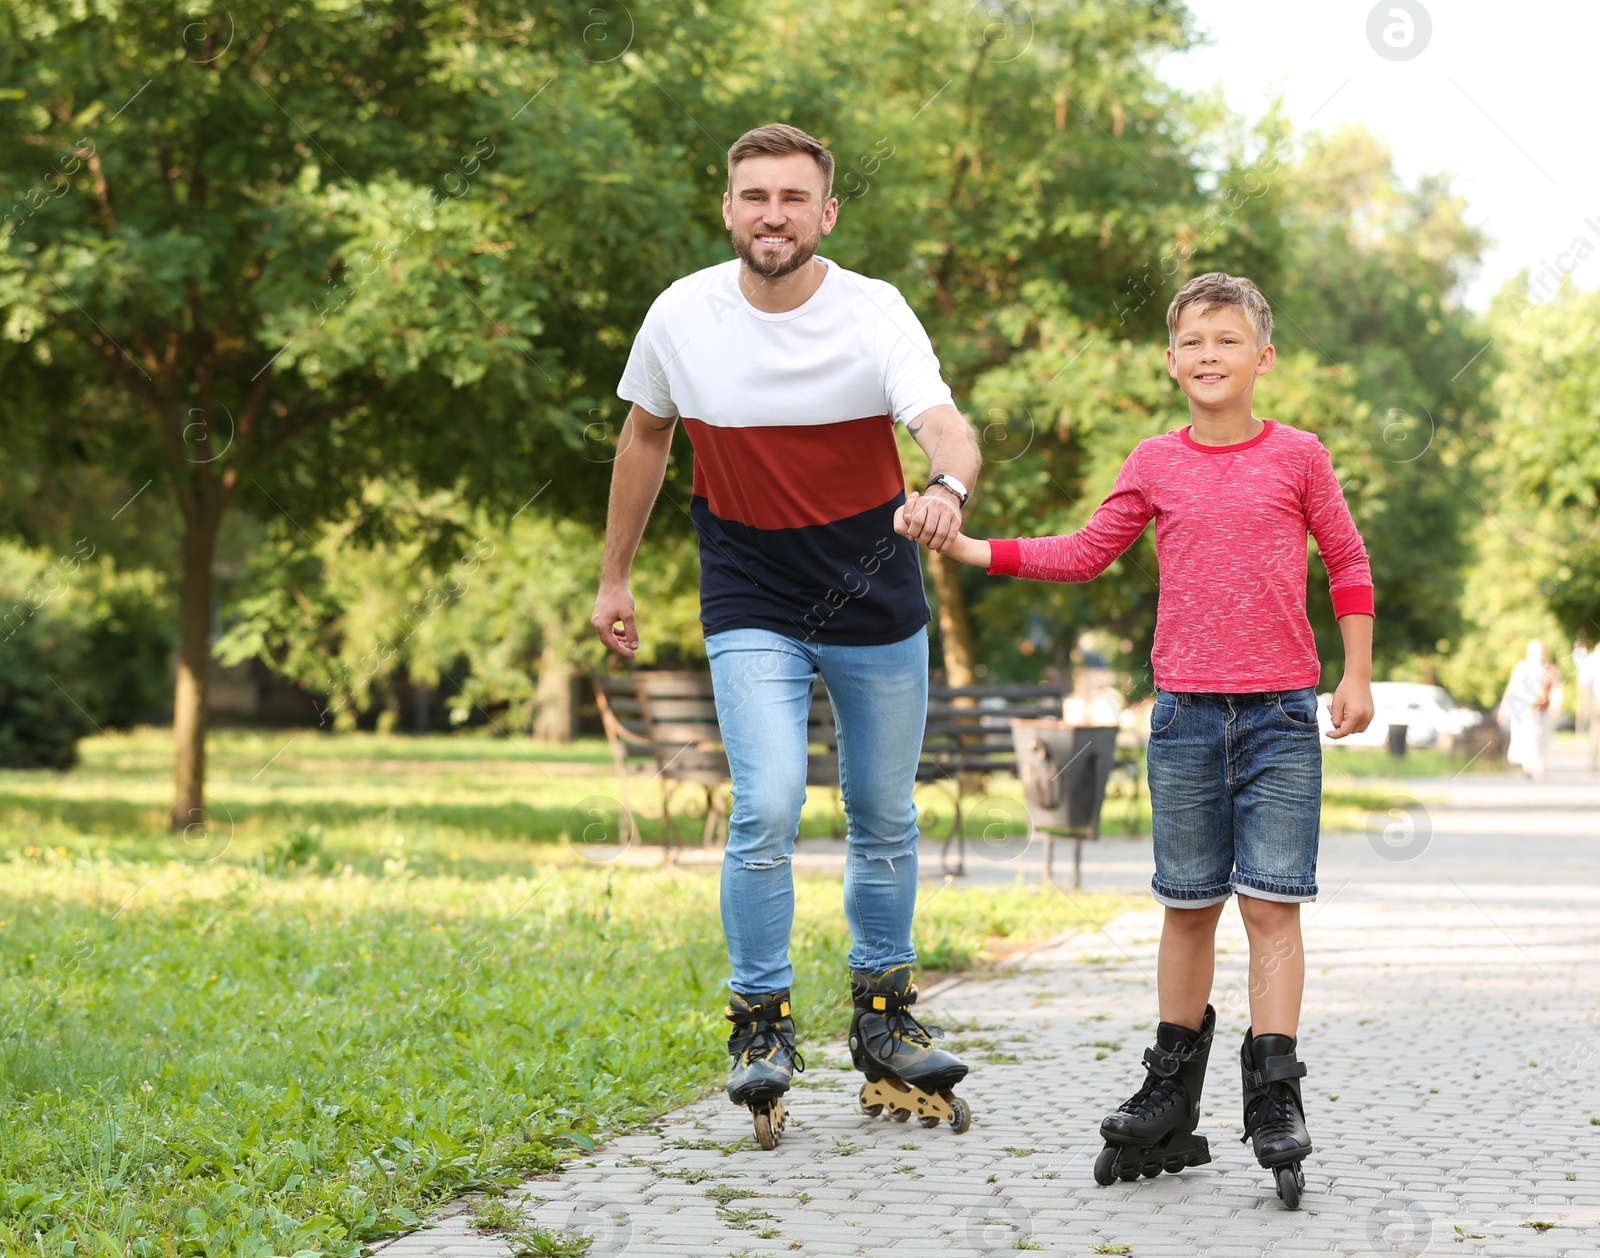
left=1149, top=688, right=1322, bottom=909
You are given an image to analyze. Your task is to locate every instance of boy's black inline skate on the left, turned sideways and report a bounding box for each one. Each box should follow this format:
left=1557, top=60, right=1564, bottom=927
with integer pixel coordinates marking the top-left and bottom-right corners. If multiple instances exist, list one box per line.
left=1094, top=1005, right=1216, bottom=1188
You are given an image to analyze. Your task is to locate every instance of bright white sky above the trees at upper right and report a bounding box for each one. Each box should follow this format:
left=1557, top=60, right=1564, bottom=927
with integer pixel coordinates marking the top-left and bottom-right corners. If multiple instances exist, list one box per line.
left=1160, top=0, right=1600, bottom=309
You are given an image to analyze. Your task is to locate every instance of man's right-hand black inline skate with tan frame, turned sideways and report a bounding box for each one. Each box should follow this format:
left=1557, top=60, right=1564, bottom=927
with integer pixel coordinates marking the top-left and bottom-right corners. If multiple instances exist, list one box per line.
left=850, top=965, right=973, bottom=1135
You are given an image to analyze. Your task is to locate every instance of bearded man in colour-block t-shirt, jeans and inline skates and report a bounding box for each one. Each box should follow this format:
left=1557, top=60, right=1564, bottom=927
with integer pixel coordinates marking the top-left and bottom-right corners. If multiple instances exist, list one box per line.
left=592, top=123, right=979, bottom=1149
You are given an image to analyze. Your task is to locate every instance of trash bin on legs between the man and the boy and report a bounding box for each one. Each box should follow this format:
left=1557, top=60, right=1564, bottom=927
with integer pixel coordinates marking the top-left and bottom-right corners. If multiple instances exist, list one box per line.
left=1011, top=720, right=1117, bottom=887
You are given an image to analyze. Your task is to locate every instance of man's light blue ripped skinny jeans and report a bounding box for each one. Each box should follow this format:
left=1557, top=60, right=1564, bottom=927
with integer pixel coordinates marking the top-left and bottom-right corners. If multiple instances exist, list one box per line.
left=706, top=629, right=928, bottom=996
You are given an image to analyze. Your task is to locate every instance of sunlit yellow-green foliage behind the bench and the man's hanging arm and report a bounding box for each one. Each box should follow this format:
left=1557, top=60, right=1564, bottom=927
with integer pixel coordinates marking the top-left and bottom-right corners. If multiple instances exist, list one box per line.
left=218, top=482, right=699, bottom=730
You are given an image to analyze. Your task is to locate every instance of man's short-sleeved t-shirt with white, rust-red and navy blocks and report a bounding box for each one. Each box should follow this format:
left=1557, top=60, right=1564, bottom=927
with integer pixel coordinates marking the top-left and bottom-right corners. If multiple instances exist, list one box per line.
left=618, top=259, right=952, bottom=645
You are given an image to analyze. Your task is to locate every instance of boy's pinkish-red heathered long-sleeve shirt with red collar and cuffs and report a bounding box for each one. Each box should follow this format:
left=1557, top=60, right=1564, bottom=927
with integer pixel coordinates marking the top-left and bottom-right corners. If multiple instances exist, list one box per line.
left=989, top=419, right=1373, bottom=695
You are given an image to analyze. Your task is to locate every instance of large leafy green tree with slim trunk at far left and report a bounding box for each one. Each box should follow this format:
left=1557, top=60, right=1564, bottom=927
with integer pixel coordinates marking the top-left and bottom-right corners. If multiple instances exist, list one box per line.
left=0, top=0, right=714, bottom=829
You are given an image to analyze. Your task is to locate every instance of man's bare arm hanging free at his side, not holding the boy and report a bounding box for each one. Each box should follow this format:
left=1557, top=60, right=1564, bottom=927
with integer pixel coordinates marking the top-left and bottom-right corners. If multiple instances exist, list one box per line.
left=589, top=405, right=677, bottom=659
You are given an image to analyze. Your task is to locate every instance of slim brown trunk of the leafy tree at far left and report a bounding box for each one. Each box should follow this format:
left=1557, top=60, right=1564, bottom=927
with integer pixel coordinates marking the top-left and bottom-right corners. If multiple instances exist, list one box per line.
left=168, top=495, right=222, bottom=832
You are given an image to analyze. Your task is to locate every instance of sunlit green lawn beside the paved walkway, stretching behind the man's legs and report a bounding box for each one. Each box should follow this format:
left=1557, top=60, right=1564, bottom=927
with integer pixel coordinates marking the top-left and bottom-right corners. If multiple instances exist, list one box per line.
left=0, top=731, right=1128, bottom=1256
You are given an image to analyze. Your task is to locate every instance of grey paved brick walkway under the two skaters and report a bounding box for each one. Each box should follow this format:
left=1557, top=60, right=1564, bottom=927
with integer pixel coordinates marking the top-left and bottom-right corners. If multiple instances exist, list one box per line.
left=382, top=749, right=1600, bottom=1258
